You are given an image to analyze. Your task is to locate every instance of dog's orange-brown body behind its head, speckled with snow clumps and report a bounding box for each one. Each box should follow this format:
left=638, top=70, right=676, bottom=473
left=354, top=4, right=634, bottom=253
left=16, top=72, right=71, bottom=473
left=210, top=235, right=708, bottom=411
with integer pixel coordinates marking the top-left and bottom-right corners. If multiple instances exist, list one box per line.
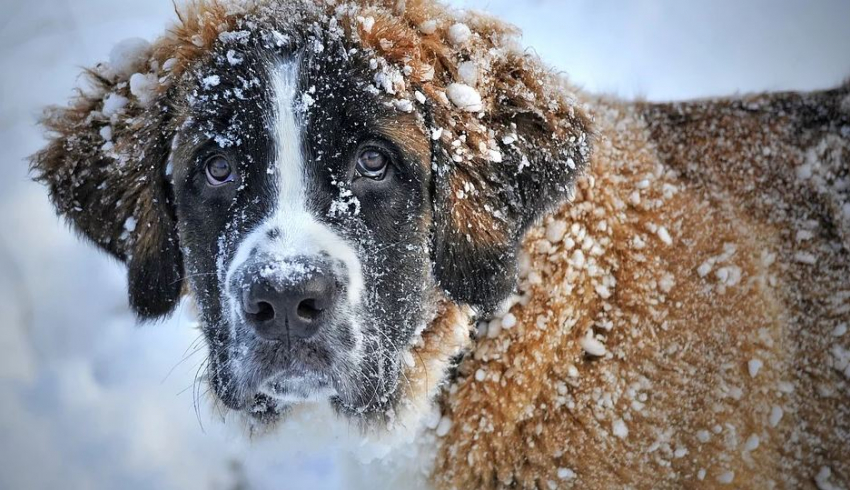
left=438, top=85, right=850, bottom=488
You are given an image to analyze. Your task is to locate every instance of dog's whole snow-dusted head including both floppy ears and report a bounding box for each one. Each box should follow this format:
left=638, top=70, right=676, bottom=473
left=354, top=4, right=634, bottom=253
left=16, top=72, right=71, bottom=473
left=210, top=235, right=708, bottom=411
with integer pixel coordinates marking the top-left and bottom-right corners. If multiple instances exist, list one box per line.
left=33, top=0, right=588, bottom=428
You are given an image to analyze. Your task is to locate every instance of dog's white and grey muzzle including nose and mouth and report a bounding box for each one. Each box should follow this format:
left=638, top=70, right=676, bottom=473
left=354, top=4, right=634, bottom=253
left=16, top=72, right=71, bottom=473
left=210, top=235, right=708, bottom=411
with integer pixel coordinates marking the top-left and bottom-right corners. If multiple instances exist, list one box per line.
left=222, top=225, right=363, bottom=403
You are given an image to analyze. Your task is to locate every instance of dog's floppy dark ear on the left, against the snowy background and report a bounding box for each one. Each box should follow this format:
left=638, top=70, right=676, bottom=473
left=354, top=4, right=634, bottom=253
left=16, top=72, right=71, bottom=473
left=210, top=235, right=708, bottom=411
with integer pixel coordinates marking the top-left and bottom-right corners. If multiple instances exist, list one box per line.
left=31, top=68, right=183, bottom=320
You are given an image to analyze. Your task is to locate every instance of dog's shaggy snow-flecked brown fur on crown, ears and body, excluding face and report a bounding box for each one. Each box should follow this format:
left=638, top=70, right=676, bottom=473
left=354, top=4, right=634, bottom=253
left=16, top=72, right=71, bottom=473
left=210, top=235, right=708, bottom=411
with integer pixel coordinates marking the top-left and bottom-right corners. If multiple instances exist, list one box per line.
left=33, top=0, right=850, bottom=489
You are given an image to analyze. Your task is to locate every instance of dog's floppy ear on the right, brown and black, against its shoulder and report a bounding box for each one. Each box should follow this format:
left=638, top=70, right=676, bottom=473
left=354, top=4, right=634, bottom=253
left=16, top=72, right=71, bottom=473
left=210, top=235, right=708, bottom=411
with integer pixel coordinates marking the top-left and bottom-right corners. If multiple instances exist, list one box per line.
left=432, top=61, right=590, bottom=312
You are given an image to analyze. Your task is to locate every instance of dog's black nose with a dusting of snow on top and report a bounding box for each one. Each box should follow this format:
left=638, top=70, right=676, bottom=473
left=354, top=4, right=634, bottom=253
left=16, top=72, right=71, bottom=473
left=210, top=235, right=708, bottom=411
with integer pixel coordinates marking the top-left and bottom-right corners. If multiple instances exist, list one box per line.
left=242, top=259, right=338, bottom=341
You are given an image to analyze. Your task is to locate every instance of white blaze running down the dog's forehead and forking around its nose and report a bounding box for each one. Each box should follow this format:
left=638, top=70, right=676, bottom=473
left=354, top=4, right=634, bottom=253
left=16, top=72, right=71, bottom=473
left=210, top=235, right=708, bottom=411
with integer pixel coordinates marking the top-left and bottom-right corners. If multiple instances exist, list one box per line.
left=222, top=59, right=363, bottom=308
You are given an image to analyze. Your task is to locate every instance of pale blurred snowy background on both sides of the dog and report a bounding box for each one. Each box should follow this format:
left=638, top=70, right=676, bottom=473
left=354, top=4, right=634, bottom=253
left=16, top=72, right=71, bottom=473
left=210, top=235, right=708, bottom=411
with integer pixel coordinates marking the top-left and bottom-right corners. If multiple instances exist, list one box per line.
left=0, top=0, right=850, bottom=490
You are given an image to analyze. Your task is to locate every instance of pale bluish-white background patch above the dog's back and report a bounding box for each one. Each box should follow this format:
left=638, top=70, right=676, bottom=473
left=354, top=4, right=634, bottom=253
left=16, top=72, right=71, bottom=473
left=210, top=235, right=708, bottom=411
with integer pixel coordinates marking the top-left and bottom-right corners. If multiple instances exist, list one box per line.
left=455, top=0, right=850, bottom=99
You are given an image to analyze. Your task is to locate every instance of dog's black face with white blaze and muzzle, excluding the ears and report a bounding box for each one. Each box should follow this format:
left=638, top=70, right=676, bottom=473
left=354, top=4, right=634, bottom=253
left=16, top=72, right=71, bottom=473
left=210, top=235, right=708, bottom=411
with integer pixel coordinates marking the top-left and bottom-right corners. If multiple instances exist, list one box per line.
left=171, top=43, right=436, bottom=420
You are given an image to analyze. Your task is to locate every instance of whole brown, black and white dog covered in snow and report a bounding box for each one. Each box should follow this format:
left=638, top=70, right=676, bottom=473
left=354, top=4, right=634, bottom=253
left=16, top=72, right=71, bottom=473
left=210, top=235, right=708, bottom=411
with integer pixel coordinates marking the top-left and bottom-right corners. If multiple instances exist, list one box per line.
left=31, top=0, right=850, bottom=489
